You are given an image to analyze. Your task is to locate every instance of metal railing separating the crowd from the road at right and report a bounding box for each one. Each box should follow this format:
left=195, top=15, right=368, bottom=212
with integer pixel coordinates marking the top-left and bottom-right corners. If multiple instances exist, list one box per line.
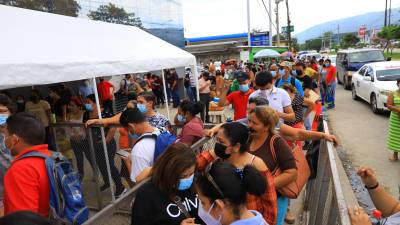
left=304, top=121, right=358, bottom=225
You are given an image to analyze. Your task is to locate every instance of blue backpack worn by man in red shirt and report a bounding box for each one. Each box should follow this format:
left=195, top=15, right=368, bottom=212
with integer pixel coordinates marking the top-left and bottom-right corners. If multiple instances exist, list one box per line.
left=18, top=151, right=89, bottom=225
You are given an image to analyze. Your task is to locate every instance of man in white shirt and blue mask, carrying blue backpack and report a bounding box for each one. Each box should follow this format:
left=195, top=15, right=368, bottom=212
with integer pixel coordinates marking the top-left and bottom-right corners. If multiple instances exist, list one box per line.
left=119, top=108, right=160, bottom=182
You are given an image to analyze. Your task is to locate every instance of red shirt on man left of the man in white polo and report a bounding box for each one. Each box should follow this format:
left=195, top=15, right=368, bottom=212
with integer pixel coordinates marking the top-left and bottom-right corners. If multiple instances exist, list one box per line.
left=226, top=89, right=254, bottom=121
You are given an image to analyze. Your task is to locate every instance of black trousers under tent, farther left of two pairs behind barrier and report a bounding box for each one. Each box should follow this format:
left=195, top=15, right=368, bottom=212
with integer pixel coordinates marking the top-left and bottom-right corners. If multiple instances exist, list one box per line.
left=70, top=139, right=95, bottom=180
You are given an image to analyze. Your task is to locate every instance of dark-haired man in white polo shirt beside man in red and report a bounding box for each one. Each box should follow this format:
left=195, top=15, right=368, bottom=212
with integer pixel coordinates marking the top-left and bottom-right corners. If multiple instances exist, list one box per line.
left=249, top=71, right=296, bottom=123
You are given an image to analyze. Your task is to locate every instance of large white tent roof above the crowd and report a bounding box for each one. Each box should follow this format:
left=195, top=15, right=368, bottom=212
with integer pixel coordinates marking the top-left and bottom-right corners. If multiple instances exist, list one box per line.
left=0, top=5, right=196, bottom=89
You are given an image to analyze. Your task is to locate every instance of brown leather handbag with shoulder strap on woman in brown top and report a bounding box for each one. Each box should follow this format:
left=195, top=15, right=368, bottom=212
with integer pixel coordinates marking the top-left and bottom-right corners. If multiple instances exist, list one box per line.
left=270, top=135, right=311, bottom=199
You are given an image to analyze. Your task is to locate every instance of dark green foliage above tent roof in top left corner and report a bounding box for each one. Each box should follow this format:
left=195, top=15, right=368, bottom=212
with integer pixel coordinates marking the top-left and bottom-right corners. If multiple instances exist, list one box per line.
left=3, top=0, right=81, bottom=17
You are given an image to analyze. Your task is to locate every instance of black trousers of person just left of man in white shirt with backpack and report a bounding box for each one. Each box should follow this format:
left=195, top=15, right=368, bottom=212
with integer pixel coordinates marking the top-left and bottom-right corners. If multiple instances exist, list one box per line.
left=94, top=139, right=124, bottom=191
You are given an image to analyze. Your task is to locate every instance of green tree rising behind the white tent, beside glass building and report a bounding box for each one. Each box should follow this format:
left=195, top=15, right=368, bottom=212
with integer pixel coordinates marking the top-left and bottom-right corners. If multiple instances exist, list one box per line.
left=88, top=3, right=143, bottom=29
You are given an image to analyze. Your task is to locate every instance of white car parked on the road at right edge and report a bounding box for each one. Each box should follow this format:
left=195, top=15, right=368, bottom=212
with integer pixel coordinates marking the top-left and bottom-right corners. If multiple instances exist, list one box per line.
left=351, top=61, right=400, bottom=113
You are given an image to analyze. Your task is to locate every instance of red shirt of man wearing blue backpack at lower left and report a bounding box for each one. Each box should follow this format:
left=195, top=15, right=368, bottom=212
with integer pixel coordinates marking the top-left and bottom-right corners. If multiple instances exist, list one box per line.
left=4, top=145, right=50, bottom=217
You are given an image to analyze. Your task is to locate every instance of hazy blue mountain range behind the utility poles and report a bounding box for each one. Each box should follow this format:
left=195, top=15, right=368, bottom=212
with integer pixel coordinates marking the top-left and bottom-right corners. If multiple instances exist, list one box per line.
left=295, top=8, right=400, bottom=44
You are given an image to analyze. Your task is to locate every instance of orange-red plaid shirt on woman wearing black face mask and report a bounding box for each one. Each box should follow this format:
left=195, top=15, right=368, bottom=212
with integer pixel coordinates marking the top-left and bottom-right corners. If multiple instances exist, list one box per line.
left=197, top=151, right=278, bottom=225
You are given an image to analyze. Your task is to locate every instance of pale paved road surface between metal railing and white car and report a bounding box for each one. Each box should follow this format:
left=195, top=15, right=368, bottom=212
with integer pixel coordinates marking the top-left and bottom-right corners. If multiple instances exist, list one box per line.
left=328, top=83, right=400, bottom=197
